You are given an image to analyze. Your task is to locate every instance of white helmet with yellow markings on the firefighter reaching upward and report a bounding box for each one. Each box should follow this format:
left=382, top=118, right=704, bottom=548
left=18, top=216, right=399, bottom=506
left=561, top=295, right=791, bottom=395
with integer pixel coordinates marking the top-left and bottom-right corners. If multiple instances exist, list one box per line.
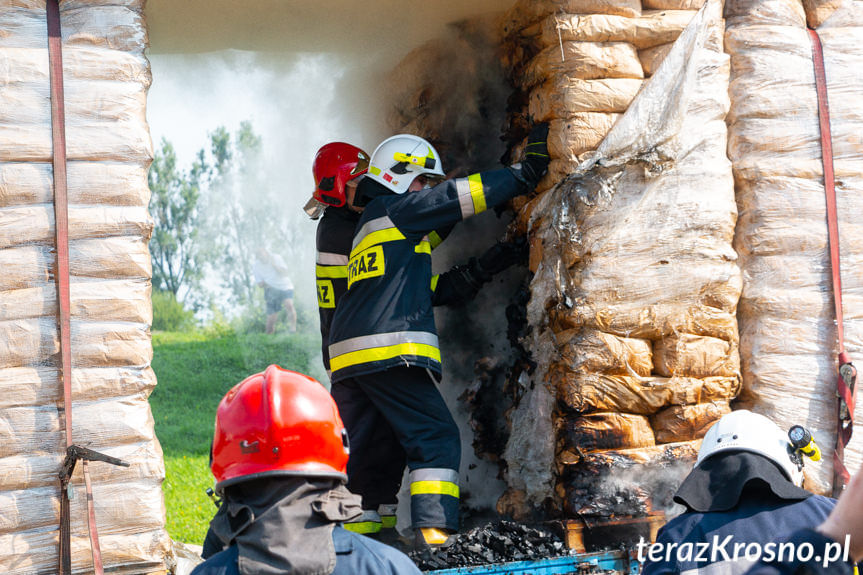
left=366, top=134, right=446, bottom=194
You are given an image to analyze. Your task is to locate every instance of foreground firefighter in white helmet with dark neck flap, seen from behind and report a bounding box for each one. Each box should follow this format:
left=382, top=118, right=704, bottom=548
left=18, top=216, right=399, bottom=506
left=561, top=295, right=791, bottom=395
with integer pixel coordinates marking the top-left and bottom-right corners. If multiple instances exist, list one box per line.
left=639, top=410, right=836, bottom=575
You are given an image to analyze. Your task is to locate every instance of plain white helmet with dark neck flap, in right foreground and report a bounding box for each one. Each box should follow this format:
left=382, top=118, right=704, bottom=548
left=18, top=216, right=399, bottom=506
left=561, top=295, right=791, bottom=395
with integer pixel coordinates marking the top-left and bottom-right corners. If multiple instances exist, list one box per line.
left=695, top=409, right=803, bottom=487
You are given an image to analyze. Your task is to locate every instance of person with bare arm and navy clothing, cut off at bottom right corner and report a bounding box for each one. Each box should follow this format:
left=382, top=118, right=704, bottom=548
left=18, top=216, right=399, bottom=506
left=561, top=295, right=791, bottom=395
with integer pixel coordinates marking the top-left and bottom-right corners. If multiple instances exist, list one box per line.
left=746, top=460, right=863, bottom=575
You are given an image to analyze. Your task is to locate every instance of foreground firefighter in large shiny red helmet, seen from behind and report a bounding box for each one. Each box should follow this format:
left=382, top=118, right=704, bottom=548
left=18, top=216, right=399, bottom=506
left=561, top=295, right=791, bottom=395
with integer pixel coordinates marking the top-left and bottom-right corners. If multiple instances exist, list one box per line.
left=192, top=365, right=420, bottom=575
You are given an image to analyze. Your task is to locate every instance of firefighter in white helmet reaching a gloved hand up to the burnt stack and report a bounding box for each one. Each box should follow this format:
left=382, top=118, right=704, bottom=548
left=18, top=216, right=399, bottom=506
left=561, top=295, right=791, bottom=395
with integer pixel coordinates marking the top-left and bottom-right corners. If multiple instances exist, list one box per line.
left=329, top=125, right=549, bottom=545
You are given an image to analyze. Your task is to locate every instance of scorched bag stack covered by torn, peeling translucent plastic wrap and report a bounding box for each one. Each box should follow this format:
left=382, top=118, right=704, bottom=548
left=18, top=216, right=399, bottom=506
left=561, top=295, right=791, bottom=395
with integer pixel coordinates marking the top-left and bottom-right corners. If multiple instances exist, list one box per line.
left=500, top=1, right=742, bottom=518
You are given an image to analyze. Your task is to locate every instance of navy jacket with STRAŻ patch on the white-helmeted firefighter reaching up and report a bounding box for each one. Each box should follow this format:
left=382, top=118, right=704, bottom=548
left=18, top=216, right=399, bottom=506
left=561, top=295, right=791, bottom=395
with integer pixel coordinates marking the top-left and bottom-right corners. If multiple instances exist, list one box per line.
left=329, top=168, right=528, bottom=381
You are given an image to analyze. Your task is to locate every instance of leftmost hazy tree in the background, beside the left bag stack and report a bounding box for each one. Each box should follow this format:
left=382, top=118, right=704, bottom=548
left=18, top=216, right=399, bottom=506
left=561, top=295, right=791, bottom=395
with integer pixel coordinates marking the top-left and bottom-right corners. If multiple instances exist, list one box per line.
left=147, top=138, right=208, bottom=299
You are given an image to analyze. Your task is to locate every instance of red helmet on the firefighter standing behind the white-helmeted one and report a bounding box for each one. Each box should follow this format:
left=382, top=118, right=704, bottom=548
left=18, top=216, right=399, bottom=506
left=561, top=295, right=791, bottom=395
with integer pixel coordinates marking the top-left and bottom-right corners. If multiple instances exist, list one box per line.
left=312, top=142, right=369, bottom=208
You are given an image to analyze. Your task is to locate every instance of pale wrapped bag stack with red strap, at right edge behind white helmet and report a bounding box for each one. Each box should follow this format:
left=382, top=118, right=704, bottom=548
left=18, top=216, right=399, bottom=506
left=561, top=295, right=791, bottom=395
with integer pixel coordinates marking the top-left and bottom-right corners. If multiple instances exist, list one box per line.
left=726, top=0, right=863, bottom=494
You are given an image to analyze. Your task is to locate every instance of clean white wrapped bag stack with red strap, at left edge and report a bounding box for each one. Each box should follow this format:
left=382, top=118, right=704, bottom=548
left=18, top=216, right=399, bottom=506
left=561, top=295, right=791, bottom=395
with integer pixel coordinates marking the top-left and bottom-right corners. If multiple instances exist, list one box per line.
left=0, top=0, right=170, bottom=574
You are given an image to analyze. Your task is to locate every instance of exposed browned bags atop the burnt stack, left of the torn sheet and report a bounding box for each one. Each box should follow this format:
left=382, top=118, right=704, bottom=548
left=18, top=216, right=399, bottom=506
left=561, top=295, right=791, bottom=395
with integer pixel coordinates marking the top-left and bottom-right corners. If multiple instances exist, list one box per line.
left=501, top=1, right=695, bottom=199
